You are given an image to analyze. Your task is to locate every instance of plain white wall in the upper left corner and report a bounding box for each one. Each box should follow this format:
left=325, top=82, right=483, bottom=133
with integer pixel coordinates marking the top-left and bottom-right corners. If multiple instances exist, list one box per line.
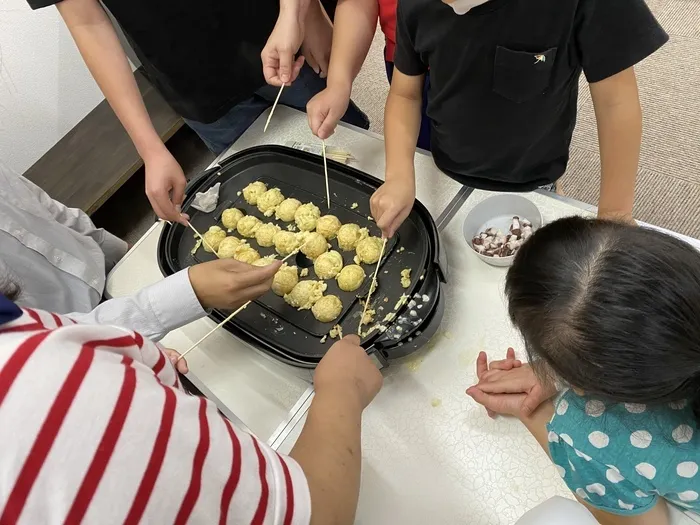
left=0, top=0, right=104, bottom=174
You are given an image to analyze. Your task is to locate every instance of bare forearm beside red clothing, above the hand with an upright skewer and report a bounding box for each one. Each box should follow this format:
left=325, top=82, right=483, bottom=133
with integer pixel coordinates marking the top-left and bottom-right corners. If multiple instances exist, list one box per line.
left=328, top=0, right=379, bottom=91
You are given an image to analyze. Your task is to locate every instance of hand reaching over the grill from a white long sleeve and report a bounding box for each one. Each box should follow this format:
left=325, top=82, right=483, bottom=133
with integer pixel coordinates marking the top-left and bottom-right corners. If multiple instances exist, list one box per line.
left=189, top=259, right=281, bottom=310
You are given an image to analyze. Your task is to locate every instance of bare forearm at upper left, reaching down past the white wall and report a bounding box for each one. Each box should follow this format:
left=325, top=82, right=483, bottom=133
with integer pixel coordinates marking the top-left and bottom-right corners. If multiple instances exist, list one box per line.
left=57, top=0, right=165, bottom=160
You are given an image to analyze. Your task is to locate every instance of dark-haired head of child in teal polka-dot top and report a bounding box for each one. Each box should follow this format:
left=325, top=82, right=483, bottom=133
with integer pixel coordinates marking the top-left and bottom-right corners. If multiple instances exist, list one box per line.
left=506, top=217, right=700, bottom=416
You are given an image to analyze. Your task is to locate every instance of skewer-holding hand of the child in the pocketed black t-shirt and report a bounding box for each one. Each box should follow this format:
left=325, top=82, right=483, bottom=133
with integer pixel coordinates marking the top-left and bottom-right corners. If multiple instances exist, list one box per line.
left=369, top=178, right=416, bottom=239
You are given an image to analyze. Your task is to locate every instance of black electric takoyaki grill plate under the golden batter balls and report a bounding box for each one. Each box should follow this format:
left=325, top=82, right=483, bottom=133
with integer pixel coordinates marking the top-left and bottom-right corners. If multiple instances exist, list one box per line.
left=158, top=146, right=446, bottom=368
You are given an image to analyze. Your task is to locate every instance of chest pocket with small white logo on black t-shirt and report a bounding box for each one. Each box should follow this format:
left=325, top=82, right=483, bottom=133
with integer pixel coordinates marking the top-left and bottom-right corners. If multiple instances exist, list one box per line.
left=493, top=46, right=557, bottom=104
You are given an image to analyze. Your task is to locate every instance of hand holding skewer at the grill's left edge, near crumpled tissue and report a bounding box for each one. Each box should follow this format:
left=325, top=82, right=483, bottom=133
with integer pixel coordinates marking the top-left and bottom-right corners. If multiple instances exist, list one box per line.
left=144, top=148, right=189, bottom=224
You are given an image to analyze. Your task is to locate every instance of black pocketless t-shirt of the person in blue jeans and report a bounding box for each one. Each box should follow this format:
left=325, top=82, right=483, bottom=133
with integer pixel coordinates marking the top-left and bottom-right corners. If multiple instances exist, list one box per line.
left=28, top=0, right=334, bottom=122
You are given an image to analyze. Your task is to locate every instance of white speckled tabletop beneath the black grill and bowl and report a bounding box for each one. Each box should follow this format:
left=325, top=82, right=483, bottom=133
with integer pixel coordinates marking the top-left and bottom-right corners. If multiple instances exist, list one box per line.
left=107, top=107, right=700, bottom=525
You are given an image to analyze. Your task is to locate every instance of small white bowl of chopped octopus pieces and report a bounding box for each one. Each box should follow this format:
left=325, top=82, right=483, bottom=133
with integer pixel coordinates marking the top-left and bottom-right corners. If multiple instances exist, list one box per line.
left=463, top=193, right=542, bottom=266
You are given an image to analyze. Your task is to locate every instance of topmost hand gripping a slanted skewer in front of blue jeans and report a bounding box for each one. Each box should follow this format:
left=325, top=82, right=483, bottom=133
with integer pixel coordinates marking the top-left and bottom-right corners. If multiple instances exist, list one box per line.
left=260, top=9, right=304, bottom=86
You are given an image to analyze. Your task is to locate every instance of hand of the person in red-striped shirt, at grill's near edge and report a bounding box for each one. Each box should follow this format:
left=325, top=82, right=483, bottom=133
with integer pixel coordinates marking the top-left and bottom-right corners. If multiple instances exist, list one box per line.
left=314, top=335, right=384, bottom=409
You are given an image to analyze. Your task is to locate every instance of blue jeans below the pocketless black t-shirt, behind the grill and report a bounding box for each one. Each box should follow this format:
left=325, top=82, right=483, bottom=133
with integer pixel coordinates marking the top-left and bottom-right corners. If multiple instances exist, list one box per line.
left=185, top=64, right=369, bottom=155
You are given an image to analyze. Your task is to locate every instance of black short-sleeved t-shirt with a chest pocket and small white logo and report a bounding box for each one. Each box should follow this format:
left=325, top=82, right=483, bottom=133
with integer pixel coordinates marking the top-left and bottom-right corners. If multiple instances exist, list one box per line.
left=394, top=0, right=668, bottom=191
